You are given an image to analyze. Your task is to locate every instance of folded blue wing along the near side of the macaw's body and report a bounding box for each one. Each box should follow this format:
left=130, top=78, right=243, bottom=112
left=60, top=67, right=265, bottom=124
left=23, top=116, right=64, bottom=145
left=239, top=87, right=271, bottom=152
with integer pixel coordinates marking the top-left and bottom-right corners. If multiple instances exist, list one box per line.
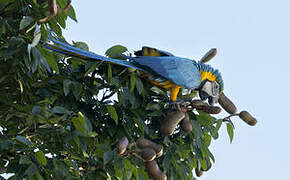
left=129, top=56, right=201, bottom=89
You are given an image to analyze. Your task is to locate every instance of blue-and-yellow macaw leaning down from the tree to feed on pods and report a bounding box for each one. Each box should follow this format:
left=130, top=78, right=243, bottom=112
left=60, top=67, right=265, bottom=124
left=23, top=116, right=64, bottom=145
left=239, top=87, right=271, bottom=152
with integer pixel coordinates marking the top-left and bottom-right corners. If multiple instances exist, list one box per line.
left=41, top=39, right=224, bottom=105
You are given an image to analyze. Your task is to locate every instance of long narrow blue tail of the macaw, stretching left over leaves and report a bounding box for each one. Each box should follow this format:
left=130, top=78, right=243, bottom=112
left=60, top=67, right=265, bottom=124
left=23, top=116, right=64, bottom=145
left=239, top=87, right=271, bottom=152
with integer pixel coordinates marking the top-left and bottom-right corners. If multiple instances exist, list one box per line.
left=40, top=39, right=146, bottom=71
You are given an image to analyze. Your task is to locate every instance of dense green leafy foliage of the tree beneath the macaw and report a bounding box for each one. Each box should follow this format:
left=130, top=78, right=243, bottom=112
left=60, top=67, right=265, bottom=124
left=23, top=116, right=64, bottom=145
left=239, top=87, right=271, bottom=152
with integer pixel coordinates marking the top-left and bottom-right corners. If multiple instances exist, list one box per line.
left=0, top=0, right=233, bottom=180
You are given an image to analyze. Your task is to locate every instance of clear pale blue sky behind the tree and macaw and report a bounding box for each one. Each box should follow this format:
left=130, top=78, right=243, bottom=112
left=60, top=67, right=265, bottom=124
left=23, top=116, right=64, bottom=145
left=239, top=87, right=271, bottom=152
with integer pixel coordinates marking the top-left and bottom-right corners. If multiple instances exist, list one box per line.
left=64, top=0, right=290, bottom=180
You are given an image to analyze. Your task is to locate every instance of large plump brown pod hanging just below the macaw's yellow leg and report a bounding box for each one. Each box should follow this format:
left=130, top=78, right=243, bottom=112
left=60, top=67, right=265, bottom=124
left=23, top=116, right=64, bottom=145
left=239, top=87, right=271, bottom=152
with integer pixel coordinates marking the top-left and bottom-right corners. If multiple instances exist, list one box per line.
left=160, top=110, right=185, bottom=136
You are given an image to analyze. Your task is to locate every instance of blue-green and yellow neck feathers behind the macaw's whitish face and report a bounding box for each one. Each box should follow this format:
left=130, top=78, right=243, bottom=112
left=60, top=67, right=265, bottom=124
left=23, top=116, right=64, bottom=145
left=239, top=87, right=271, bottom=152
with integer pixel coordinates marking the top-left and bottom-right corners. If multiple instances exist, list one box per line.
left=197, top=63, right=224, bottom=90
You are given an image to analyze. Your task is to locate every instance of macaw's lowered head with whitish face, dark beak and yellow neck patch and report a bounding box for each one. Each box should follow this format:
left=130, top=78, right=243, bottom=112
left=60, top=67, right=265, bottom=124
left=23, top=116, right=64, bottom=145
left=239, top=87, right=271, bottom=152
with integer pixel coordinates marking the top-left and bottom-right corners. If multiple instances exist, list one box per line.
left=198, top=63, right=224, bottom=105
